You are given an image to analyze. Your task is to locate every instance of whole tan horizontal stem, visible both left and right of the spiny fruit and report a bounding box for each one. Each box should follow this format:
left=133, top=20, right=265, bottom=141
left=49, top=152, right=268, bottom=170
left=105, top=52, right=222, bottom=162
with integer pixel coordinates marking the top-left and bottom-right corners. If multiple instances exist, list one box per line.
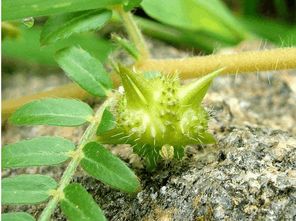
left=2, top=48, right=296, bottom=120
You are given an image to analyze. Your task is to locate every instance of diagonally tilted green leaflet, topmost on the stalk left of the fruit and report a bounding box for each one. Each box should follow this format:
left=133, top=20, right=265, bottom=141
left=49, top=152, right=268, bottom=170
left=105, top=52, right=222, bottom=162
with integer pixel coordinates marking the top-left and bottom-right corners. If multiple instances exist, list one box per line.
left=56, top=47, right=112, bottom=96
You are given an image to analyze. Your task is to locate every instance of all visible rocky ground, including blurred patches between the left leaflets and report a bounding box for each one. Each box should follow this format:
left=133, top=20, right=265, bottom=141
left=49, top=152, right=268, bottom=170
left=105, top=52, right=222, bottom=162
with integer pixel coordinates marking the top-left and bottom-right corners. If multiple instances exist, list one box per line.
left=2, top=42, right=296, bottom=221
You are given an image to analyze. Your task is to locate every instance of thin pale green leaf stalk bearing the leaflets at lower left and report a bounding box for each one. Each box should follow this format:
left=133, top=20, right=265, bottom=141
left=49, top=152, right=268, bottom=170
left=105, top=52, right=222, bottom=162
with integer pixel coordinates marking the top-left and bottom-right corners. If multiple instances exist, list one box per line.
left=38, top=99, right=110, bottom=221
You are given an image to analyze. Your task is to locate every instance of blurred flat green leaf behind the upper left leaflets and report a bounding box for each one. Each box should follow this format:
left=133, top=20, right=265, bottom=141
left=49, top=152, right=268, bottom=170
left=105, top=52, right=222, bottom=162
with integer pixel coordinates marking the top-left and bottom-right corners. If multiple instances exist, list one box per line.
left=2, top=26, right=114, bottom=67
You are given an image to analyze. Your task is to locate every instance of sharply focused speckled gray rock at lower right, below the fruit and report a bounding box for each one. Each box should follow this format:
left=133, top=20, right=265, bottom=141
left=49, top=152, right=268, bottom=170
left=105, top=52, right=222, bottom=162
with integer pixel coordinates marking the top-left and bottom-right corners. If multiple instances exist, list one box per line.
left=76, top=127, right=296, bottom=220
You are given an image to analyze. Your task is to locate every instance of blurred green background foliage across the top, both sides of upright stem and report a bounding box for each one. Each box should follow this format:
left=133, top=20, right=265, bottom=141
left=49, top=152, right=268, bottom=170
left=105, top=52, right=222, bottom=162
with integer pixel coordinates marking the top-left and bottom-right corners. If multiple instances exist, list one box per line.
left=2, top=0, right=296, bottom=67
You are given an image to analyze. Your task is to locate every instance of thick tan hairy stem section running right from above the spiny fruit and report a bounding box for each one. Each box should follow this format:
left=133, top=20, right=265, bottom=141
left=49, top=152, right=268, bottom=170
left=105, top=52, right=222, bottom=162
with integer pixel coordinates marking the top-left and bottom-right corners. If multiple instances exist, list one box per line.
left=137, top=48, right=296, bottom=79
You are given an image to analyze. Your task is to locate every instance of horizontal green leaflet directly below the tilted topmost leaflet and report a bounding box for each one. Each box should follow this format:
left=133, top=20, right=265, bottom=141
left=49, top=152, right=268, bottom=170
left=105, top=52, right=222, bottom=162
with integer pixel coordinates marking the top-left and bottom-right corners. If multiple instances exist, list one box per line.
left=10, top=98, right=93, bottom=127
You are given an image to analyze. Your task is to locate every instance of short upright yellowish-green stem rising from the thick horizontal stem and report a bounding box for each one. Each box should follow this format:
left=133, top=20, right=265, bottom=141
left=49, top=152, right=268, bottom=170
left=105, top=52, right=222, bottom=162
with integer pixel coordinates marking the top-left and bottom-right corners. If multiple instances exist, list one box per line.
left=116, top=6, right=150, bottom=59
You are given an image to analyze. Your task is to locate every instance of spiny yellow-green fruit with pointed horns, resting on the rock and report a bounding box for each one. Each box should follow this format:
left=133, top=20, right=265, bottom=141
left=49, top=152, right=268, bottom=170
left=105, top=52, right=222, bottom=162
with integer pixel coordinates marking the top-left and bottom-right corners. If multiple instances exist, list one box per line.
left=97, top=66, right=220, bottom=170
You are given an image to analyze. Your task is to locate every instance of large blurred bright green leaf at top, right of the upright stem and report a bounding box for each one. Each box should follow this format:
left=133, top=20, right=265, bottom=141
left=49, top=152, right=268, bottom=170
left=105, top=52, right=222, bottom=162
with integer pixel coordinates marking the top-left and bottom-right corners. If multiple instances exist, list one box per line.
left=141, top=0, right=248, bottom=41
